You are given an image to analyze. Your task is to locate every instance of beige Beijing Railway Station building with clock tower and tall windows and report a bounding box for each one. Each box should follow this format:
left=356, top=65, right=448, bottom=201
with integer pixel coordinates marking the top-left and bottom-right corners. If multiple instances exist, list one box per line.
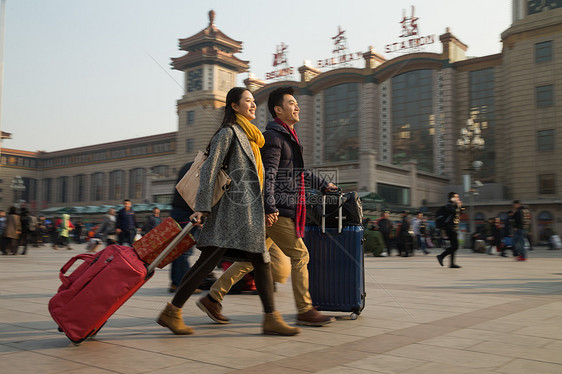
left=0, top=0, right=562, bottom=241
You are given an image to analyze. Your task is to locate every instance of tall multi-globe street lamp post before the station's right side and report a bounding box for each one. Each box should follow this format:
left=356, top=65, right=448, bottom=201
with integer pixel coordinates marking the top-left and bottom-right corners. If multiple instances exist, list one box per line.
left=457, top=118, right=485, bottom=242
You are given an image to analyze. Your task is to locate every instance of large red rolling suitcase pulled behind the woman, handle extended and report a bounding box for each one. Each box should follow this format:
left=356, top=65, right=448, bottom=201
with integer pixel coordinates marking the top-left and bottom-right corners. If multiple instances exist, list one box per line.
left=49, top=219, right=197, bottom=344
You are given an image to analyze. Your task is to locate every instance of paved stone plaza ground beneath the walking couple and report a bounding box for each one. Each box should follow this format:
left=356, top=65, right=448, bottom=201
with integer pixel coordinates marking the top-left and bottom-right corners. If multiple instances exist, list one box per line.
left=0, top=245, right=562, bottom=374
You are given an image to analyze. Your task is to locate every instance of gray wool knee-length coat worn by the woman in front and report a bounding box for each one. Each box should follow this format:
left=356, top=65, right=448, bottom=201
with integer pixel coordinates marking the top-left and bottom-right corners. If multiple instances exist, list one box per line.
left=195, top=124, right=265, bottom=253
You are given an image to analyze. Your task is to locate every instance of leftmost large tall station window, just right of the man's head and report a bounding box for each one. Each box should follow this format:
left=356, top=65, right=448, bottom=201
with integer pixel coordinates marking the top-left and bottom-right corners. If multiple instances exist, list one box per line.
left=324, top=83, right=359, bottom=162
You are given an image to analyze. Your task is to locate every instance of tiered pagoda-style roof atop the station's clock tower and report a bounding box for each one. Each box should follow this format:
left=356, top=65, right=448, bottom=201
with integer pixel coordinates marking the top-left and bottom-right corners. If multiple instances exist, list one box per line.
left=171, top=10, right=249, bottom=73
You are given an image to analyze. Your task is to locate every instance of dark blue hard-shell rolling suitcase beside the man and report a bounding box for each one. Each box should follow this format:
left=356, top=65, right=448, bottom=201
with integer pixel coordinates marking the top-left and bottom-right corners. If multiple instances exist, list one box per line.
left=304, top=196, right=366, bottom=319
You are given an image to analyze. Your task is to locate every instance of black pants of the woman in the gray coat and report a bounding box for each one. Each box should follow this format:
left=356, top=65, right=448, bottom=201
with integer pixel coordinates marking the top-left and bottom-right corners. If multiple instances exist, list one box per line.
left=172, top=247, right=275, bottom=313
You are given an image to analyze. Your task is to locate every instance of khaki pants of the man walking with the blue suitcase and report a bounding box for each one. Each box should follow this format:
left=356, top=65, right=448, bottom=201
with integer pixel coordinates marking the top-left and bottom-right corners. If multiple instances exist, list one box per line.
left=209, top=217, right=312, bottom=314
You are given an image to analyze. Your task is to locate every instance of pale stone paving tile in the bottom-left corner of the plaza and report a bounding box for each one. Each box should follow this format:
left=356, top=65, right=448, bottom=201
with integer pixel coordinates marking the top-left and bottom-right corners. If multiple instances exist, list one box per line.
left=0, top=351, right=85, bottom=374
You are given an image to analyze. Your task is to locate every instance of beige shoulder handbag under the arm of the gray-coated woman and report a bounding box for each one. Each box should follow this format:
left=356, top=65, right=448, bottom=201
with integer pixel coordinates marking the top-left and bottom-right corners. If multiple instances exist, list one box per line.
left=176, top=151, right=231, bottom=211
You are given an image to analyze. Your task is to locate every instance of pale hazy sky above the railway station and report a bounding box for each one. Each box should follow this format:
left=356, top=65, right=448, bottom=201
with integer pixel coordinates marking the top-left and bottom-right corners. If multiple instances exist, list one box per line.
left=1, top=0, right=511, bottom=152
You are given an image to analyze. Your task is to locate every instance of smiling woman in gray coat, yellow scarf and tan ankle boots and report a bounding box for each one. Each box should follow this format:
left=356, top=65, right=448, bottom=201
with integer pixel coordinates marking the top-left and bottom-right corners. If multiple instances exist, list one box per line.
left=157, top=87, right=300, bottom=336
